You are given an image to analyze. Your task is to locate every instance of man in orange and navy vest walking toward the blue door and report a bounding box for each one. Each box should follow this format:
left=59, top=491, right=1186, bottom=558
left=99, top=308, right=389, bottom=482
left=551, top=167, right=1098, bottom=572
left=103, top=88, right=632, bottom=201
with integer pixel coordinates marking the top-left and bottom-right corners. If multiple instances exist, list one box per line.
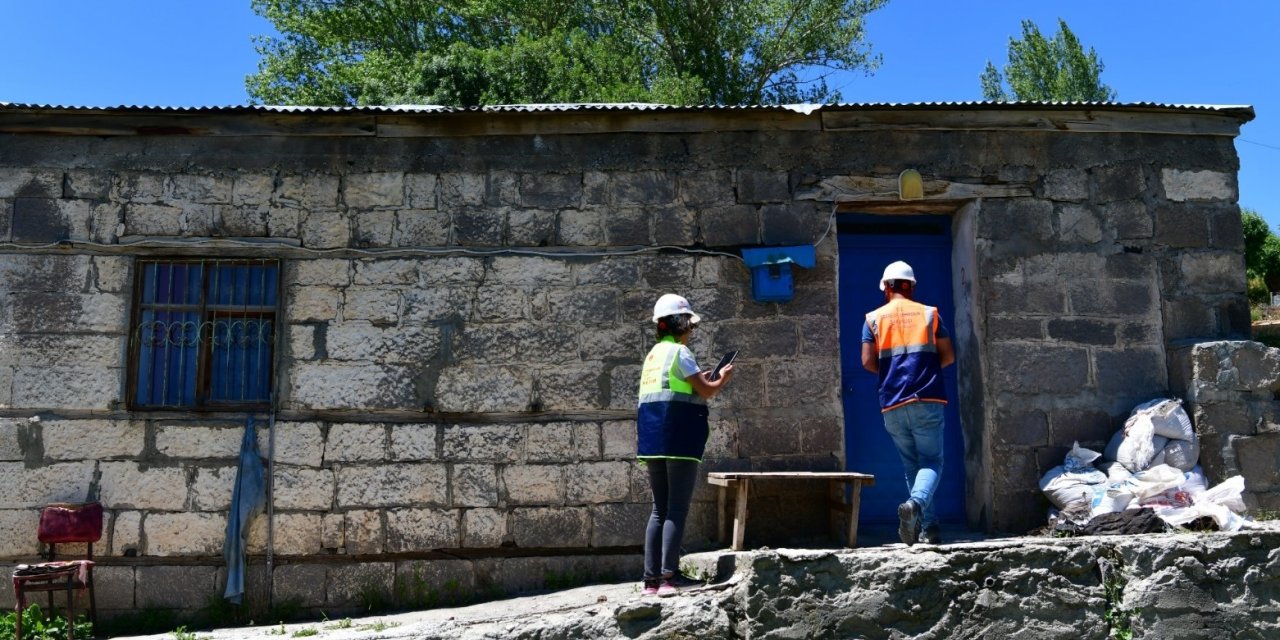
left=863, top=261, right=955, bottom=545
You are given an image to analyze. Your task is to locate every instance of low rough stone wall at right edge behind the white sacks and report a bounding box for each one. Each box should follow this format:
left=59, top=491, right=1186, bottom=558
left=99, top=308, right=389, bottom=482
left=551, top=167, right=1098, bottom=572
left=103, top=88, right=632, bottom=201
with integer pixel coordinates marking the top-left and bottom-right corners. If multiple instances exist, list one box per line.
left=1175, top=340, right=1280, bottom=513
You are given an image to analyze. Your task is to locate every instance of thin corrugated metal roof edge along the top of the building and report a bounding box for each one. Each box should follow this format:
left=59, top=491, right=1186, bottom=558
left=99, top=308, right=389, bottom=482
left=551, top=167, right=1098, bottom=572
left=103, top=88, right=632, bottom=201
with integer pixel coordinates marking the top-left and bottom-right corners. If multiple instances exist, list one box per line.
left=0, top=101, right=1254, bottom=120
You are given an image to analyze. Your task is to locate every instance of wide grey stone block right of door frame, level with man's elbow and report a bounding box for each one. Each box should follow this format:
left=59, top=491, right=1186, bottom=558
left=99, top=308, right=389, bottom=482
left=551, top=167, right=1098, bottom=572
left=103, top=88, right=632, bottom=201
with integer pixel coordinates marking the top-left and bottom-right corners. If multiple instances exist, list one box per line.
left=987, top=342, right=1089, bottom=394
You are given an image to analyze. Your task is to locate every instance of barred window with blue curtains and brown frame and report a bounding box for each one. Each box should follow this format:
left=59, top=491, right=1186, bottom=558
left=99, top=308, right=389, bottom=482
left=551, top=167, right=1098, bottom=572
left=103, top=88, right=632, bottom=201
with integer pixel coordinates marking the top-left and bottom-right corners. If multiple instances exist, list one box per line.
left=129, top=259, right=280, bottom=410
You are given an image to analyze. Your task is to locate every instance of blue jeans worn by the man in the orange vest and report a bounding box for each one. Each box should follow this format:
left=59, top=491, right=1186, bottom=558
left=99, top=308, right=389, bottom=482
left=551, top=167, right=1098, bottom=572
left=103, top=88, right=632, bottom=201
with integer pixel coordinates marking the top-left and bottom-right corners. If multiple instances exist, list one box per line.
left=882, top=402, right=946, bottom=526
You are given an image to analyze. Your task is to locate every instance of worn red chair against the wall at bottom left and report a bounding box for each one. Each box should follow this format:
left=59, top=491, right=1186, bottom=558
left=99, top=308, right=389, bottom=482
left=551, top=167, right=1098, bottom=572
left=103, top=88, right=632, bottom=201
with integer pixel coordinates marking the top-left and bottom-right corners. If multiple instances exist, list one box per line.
left=13, top=502, right=102, bottom=640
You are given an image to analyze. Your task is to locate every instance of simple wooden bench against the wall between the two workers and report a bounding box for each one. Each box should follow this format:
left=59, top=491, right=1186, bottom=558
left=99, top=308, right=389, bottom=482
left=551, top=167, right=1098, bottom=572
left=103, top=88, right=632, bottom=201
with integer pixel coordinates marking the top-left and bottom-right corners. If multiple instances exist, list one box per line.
left=707, top=471, right=876, bottom=552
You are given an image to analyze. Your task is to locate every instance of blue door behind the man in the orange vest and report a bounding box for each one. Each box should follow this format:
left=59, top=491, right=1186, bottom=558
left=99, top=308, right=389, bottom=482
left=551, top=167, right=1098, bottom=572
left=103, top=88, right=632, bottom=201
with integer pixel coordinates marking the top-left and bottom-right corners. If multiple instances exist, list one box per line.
left=838, top=215, right=965, bottom=525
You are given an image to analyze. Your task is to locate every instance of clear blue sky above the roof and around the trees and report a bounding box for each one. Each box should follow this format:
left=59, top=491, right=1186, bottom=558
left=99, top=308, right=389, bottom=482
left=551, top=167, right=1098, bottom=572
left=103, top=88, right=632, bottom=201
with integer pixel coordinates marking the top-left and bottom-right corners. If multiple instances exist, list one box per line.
left=0, top=0, right=1280, bottom=233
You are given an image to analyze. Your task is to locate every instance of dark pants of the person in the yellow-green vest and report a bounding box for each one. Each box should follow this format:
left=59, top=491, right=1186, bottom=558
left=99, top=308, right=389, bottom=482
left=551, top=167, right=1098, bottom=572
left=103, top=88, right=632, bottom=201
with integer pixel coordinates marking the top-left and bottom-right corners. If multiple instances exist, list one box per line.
left=644, top=460, right=698, bottom=580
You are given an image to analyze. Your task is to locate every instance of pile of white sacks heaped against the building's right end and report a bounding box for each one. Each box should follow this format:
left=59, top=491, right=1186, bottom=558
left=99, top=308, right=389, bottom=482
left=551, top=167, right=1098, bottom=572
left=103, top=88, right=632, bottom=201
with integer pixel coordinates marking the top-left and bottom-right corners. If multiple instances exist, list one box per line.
left=1039, top=399, right=1245, bottom=534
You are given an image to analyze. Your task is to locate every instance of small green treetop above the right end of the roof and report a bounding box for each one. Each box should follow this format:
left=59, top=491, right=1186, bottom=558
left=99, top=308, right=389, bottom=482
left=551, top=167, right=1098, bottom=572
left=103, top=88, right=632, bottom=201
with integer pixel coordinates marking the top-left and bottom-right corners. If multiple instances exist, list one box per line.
left=980, top=18, right=1116, bottom=102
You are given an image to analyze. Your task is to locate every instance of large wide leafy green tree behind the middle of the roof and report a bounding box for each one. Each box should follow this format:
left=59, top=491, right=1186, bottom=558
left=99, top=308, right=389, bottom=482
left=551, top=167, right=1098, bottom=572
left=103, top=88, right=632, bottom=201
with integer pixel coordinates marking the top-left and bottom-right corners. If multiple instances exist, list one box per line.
left=246, top=0, right=888, bottom=106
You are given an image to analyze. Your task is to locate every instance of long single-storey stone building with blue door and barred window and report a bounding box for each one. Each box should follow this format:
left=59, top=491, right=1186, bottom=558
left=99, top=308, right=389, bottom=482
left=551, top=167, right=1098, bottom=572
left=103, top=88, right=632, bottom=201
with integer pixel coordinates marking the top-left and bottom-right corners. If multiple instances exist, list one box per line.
left=0, top=104, right=1259, bottom=611
